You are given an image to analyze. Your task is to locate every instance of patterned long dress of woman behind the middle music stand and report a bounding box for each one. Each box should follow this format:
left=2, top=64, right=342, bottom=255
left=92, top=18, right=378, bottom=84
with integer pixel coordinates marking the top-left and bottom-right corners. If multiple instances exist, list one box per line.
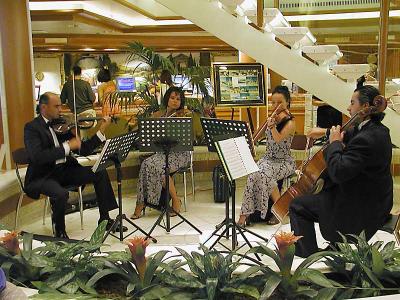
left=137, top=112, right=190, bottom=206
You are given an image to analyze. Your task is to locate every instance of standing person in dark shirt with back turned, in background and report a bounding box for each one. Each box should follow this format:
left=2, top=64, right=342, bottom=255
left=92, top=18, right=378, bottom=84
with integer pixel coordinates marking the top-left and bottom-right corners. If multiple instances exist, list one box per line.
left=60, top=66, right=96, bottom=139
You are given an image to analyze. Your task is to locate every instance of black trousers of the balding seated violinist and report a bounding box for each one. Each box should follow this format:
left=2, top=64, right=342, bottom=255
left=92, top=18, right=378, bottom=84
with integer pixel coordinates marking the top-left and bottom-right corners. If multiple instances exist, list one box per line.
left=40, top=164, right=118, bottom=231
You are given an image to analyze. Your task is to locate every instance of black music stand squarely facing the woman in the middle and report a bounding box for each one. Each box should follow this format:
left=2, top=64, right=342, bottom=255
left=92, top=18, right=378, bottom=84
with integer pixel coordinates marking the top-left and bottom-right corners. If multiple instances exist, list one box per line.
left=139, top=118, right=202, bottom=235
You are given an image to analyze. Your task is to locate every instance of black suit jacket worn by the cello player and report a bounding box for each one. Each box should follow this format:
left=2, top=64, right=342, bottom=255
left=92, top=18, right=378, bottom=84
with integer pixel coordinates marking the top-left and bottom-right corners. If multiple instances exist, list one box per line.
left=319, top=120, right=393, bottom=241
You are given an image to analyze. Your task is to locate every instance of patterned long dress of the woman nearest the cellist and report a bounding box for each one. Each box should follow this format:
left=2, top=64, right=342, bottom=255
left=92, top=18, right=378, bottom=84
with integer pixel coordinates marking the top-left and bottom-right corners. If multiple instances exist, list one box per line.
left=241, top=129, right=296, bottom=218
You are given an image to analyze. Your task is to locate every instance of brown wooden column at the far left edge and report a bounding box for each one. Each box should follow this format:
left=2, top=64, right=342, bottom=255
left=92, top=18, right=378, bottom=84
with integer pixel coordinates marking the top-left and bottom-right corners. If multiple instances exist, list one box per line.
left=0, top=0, right=34, bottom=169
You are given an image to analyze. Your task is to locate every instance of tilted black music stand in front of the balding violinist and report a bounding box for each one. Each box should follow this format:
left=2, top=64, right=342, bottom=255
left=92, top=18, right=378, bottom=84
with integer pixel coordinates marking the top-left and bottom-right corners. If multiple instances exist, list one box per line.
left=92, top=132, right=157, bottom=243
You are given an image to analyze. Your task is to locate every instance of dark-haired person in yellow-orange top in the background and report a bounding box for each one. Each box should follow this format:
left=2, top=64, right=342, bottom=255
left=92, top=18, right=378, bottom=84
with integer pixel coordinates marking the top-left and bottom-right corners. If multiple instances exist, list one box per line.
left=97, top=68, right=121, bottom=116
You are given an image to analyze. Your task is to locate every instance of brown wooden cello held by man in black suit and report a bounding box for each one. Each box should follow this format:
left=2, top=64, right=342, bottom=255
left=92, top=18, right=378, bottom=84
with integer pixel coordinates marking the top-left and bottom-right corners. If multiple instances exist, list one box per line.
left=271, top=95, right=387, bottom=224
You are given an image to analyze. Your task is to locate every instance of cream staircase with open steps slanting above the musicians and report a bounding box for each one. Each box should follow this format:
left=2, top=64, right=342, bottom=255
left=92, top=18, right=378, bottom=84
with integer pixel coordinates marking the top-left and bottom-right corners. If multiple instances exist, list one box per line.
left=155, top=0, right=400, bottom=146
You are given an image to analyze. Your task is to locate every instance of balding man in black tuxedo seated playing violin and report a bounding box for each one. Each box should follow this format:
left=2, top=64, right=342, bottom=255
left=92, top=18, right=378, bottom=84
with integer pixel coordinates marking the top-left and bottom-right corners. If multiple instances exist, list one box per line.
left=24, top=92, right=126, bottom=238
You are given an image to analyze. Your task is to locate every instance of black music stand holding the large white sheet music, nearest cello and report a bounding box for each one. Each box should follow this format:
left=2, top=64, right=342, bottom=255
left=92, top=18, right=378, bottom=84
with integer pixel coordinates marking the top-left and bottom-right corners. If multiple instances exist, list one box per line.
left=201, top=118, right=268, bottom=254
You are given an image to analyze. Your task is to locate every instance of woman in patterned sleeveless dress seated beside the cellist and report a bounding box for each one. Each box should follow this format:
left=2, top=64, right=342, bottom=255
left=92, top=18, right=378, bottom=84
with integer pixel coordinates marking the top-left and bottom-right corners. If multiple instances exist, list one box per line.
left=238, top=86, right=296, bottom=225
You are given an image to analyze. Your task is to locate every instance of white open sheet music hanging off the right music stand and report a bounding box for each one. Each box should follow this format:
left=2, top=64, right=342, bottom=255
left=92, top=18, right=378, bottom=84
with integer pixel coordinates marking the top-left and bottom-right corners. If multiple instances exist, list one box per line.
left=215, top=136, right=260, bottom=181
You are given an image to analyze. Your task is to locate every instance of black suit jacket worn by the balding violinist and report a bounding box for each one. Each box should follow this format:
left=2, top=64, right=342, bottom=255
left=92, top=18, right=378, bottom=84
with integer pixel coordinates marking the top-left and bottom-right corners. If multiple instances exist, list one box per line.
left=24, top=116, right=101, bottom=199
